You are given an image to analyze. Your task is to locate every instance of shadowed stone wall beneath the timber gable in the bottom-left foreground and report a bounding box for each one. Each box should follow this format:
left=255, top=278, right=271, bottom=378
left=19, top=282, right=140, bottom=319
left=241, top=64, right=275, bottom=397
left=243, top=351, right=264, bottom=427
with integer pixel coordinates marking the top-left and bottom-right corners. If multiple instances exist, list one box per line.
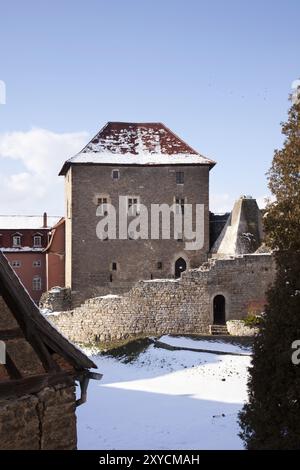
left=0, top=385, right=77, bottom=450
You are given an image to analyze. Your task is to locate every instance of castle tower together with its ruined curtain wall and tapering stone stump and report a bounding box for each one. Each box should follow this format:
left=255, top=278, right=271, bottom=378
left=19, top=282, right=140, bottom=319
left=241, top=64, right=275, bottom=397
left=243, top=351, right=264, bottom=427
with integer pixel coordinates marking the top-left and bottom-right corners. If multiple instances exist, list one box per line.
left=44, top=123, right=275, bottom=343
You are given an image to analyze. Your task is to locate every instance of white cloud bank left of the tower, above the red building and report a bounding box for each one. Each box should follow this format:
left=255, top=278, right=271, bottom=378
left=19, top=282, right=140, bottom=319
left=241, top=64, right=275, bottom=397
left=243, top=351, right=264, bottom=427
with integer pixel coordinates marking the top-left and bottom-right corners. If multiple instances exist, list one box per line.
left=0, top=128, right=89, bottom=215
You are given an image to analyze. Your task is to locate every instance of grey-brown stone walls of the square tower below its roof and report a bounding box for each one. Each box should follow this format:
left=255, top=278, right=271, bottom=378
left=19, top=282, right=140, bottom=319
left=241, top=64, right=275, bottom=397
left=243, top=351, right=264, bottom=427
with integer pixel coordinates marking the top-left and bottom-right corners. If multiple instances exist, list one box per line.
left=65, top=164, right=209, bottom=300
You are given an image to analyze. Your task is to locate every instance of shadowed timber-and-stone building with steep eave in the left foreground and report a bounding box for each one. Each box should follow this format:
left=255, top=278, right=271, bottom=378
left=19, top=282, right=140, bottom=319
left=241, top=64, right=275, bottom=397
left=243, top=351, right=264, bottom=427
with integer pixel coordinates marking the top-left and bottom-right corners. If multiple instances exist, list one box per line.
left=0, top=253, right=96, bottom=450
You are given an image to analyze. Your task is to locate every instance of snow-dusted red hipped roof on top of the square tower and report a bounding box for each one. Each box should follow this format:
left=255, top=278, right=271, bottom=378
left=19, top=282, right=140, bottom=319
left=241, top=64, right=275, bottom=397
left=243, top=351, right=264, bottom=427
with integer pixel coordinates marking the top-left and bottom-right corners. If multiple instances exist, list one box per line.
left=59, top=122, right=215, bottom=175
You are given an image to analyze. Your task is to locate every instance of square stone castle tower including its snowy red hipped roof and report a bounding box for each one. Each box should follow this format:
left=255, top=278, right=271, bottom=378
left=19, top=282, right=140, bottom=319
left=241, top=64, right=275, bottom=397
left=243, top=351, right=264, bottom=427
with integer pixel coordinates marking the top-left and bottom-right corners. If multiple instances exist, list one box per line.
left=60, top=122, right=215, bottom=298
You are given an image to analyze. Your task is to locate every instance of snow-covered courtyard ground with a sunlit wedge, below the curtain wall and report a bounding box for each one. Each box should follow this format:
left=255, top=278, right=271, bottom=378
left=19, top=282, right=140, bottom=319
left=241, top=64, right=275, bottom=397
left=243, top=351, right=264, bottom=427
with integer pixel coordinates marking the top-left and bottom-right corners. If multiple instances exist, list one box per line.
left=77, top=336, right=250, bottom=450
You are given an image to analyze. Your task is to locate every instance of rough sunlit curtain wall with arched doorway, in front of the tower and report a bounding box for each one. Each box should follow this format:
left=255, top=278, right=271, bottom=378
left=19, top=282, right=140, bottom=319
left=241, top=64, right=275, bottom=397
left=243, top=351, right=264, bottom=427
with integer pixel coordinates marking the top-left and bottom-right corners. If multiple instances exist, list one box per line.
left=48, top=254, right=275, bottom=343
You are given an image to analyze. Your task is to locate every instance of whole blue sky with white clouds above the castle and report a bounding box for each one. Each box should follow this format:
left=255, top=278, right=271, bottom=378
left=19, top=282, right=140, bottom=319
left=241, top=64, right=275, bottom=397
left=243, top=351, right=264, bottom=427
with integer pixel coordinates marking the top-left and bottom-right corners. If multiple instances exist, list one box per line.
left=0, top=0, right=300, bottom=214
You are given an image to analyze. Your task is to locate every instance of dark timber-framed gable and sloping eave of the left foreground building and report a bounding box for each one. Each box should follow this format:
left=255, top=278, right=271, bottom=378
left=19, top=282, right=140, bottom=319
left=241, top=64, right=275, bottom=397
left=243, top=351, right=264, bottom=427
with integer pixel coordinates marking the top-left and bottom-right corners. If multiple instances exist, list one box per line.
left=0, top=253, right=97, bottom=397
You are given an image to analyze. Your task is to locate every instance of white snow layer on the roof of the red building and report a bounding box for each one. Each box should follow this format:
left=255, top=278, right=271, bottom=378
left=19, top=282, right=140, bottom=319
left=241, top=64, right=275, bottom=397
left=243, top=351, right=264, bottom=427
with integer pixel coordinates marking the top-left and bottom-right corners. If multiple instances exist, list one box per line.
left=0, top=215, right=61, bottom=230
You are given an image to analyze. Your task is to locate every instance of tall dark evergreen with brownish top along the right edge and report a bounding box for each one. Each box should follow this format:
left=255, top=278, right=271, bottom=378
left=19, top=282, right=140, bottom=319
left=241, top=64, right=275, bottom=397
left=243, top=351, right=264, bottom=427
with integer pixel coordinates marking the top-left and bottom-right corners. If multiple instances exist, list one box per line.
left=239, top=93, right=300, bottom=449
